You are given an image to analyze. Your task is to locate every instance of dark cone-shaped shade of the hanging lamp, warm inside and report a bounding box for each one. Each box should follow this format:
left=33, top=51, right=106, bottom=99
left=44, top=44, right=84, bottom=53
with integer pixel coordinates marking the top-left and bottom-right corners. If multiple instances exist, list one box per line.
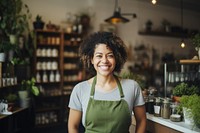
left=105, top=8, right=129, bottom=24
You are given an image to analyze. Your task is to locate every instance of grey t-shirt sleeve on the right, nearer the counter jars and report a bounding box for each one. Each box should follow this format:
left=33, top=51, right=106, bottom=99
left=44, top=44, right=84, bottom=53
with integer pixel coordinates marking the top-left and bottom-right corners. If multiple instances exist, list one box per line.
left=133, top=82, right=145, bottom=106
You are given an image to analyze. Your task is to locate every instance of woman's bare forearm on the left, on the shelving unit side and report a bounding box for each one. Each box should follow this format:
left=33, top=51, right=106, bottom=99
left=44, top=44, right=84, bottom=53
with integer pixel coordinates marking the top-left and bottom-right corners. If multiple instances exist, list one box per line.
left=68, top=109, right=82, bottom=133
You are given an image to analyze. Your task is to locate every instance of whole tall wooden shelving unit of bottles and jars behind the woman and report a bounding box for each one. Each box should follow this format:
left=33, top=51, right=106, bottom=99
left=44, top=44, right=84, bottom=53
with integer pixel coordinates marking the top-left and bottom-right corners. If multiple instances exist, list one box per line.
left=33, top=30, right=83, bottom=128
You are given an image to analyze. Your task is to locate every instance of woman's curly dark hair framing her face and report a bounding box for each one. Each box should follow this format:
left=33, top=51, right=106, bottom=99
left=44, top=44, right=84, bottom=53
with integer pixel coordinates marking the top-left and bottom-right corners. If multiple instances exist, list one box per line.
left=79, top=32, right=127, bottom=74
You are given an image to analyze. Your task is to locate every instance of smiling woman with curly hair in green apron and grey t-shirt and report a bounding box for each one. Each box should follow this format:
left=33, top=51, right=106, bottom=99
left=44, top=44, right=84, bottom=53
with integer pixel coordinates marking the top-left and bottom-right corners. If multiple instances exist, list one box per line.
left=68, top=32, right=146, bottom=133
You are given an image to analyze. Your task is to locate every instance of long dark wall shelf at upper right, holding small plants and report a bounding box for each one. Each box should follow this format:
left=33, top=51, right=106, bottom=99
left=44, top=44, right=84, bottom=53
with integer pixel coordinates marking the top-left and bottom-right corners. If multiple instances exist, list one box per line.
left=139, top=31, right=188, bottom=38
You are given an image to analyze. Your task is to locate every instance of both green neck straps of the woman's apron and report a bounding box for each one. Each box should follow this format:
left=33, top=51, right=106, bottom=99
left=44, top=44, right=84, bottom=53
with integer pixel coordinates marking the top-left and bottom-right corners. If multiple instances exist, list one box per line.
left=90, top=75, right=124, bottom=98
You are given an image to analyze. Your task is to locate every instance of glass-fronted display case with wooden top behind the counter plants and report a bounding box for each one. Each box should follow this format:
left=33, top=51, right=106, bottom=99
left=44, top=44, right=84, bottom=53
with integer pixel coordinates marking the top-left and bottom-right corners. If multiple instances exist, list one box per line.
left=164, top=60, right=200, bottom=97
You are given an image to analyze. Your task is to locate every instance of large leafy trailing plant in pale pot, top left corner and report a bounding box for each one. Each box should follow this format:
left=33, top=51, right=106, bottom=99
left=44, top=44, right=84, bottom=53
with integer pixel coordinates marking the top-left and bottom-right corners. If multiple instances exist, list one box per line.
left=0, top=0, right=31, bottom=44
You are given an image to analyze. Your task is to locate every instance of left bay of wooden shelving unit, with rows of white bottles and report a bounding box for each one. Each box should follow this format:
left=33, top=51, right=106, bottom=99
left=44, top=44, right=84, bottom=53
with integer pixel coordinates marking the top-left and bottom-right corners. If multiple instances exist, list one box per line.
left=33, top=30, right=62, bottom=127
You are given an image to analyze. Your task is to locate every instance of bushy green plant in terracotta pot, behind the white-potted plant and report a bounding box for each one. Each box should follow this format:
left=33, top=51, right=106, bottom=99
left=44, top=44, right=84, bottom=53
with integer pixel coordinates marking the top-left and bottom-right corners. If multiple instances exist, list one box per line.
left=172, top=82, right=199, bottom=102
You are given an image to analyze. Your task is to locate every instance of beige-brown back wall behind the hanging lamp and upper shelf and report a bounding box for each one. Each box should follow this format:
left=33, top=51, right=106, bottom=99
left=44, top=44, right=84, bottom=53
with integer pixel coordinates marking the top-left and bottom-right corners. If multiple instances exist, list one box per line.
left=23, top=0, right=200, bottom=69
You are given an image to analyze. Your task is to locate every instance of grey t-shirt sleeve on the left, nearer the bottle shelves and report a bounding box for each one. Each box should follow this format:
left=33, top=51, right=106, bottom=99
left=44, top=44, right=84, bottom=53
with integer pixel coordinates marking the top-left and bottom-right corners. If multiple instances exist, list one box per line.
left=68, top=84, right=82, bottom=111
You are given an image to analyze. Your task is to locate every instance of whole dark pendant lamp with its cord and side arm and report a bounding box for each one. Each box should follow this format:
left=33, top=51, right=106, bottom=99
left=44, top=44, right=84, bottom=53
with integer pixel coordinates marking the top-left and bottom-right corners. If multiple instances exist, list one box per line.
left=105, top=0, right=136, bottom=24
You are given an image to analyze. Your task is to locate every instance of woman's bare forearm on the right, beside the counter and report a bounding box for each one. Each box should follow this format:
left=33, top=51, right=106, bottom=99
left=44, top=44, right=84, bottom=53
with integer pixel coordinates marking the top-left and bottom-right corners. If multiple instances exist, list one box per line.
left=133, top=105, right=146, bottom=133
